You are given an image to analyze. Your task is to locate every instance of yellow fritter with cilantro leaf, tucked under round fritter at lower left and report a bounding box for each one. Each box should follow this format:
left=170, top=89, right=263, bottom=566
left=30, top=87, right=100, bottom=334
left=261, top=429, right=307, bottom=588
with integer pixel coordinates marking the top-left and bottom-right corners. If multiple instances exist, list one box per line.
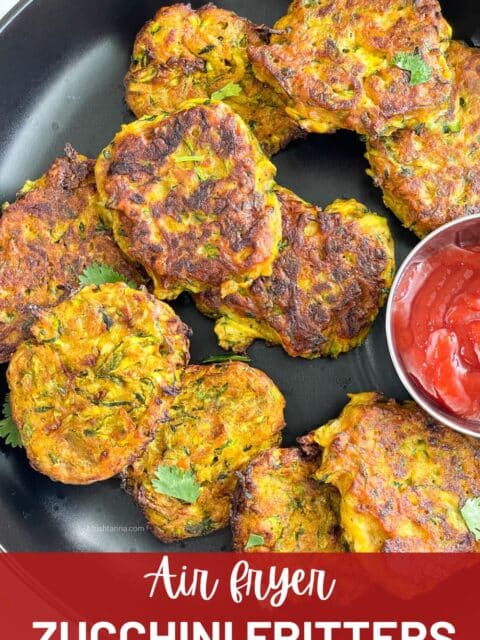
left=125, top=362, right=285, bottom=541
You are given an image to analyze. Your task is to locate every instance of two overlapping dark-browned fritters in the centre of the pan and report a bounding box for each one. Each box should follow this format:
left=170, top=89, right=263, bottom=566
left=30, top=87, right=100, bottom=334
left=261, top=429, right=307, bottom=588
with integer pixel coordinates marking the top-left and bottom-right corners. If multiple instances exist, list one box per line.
left=96, top=101, right=394, bottom=358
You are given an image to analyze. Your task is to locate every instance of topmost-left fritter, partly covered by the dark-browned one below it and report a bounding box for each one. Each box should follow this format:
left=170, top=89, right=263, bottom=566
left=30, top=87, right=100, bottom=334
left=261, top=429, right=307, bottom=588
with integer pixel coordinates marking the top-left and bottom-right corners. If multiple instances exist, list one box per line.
left=125, top=4, right=300, bottom=155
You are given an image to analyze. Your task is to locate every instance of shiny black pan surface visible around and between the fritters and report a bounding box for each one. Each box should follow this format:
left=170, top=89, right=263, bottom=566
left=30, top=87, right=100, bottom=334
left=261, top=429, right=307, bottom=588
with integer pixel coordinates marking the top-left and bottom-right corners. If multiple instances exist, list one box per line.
left=0, top=0, right=480, bottom=551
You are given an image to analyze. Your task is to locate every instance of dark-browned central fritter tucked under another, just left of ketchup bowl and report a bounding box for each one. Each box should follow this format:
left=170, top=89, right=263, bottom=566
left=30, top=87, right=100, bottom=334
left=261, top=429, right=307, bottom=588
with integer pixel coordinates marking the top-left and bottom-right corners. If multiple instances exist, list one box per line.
left=195, top=187, right=394, bottom=358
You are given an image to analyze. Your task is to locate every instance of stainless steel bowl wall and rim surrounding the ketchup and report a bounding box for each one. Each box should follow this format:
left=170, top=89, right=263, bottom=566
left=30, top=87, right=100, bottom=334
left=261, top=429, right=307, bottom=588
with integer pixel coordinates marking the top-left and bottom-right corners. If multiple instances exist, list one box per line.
left=386, top=214, right=480, bottom=438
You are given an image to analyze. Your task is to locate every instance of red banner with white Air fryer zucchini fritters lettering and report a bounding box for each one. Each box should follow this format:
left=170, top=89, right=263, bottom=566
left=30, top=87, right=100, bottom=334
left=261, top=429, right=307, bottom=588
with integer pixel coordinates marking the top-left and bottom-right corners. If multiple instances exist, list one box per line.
left=0, top=553, right=480, bottom=640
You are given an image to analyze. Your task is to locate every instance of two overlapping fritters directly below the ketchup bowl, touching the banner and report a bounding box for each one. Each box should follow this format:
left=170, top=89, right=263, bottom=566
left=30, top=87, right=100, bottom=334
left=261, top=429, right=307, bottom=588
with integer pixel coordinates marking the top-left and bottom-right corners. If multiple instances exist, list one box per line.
left=232, top=393, right=480, bottom=552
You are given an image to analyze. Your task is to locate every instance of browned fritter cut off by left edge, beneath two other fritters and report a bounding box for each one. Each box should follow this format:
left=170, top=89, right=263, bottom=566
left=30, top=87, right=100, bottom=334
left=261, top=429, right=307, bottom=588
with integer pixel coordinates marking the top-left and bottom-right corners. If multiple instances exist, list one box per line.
left=0, top=147, right=142, bottom=362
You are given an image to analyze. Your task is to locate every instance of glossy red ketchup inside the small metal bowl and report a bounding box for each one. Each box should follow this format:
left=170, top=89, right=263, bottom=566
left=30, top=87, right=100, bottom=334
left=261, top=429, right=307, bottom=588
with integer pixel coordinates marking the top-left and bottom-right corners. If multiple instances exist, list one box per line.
left=392, top=243, right=480, bottom=421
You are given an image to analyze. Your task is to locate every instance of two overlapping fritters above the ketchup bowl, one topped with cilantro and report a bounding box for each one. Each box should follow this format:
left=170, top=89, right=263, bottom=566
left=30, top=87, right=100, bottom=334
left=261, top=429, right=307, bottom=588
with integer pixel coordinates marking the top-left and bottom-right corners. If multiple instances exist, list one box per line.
left=244, top=0, right=480, bottom=237
